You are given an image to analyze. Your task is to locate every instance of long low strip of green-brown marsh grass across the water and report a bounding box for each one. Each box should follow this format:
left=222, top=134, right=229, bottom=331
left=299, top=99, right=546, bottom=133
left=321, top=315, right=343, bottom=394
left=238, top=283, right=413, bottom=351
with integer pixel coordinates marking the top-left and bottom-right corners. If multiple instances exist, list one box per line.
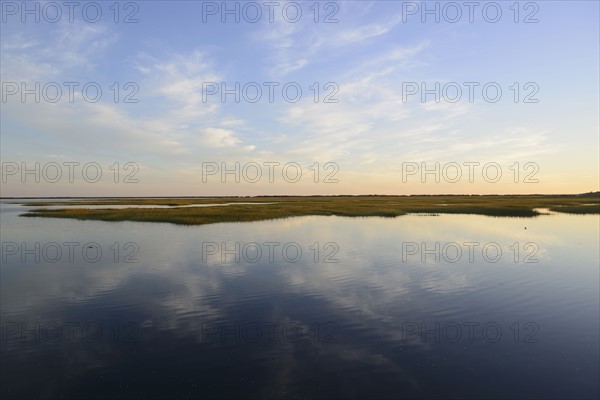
left=23, top=195, right=600, bottom=225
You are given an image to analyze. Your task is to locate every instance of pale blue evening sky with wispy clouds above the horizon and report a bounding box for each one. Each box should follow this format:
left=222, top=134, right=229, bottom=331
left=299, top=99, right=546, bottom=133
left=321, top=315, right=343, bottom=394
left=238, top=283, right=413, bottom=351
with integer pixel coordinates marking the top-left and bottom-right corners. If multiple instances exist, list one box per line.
left=0, top=1, right=600, bottom=197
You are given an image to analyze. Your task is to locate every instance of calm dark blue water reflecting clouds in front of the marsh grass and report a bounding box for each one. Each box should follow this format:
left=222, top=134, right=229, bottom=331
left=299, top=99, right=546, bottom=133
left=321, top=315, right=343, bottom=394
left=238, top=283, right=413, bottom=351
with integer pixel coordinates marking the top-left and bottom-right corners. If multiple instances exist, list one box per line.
left=0, top=203, right=600, bottom=398
